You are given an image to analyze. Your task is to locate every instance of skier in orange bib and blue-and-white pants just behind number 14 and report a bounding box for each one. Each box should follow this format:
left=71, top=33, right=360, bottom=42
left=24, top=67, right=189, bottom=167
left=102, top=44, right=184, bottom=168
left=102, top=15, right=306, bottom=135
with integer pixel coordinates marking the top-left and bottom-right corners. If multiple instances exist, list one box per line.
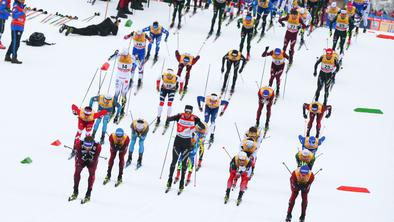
left=124, top=30, right=152, bottom=89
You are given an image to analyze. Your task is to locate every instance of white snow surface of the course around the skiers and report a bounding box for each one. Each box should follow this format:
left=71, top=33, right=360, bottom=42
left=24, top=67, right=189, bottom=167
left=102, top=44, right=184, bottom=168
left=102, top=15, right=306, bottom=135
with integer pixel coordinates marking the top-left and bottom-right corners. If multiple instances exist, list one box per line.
left=0, top=0, right=394, bottom=222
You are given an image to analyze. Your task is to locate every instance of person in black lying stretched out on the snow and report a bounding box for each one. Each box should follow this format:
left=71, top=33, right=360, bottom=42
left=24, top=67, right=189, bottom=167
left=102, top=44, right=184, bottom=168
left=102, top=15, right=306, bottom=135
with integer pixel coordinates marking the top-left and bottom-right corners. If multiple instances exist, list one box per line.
left=59, top=18, right=120, bottom=36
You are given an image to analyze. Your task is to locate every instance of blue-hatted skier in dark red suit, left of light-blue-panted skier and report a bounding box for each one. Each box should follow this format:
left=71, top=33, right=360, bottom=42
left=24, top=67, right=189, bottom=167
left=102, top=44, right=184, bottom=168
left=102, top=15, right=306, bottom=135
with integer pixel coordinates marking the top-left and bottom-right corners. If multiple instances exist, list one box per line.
left=103, top=128, right=130, bottom=186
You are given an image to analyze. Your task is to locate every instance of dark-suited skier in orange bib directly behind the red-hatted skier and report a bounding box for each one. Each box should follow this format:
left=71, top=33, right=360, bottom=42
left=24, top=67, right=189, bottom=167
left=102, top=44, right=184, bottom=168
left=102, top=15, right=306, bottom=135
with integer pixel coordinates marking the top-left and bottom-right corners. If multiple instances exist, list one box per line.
left=332, top=10, right=353, bottom=57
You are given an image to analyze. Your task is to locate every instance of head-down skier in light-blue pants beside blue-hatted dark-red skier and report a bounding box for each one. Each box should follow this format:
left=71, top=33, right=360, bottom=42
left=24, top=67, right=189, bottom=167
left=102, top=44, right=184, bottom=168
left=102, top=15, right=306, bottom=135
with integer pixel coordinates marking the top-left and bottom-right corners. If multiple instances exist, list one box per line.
left=126, top=119, right=149, bottom=168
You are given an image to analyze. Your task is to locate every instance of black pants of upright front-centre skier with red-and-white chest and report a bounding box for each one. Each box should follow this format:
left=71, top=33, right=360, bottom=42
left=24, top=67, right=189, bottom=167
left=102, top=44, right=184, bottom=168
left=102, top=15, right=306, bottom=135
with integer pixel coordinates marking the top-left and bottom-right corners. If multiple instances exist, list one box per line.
left=168, top=136, right=192, bottom=187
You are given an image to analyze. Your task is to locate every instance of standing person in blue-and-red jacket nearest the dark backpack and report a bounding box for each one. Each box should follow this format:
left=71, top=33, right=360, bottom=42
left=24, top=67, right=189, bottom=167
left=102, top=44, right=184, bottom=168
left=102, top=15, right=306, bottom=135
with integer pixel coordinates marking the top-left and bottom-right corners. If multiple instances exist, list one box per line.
left=4, top=0, right=27, bottom=64
